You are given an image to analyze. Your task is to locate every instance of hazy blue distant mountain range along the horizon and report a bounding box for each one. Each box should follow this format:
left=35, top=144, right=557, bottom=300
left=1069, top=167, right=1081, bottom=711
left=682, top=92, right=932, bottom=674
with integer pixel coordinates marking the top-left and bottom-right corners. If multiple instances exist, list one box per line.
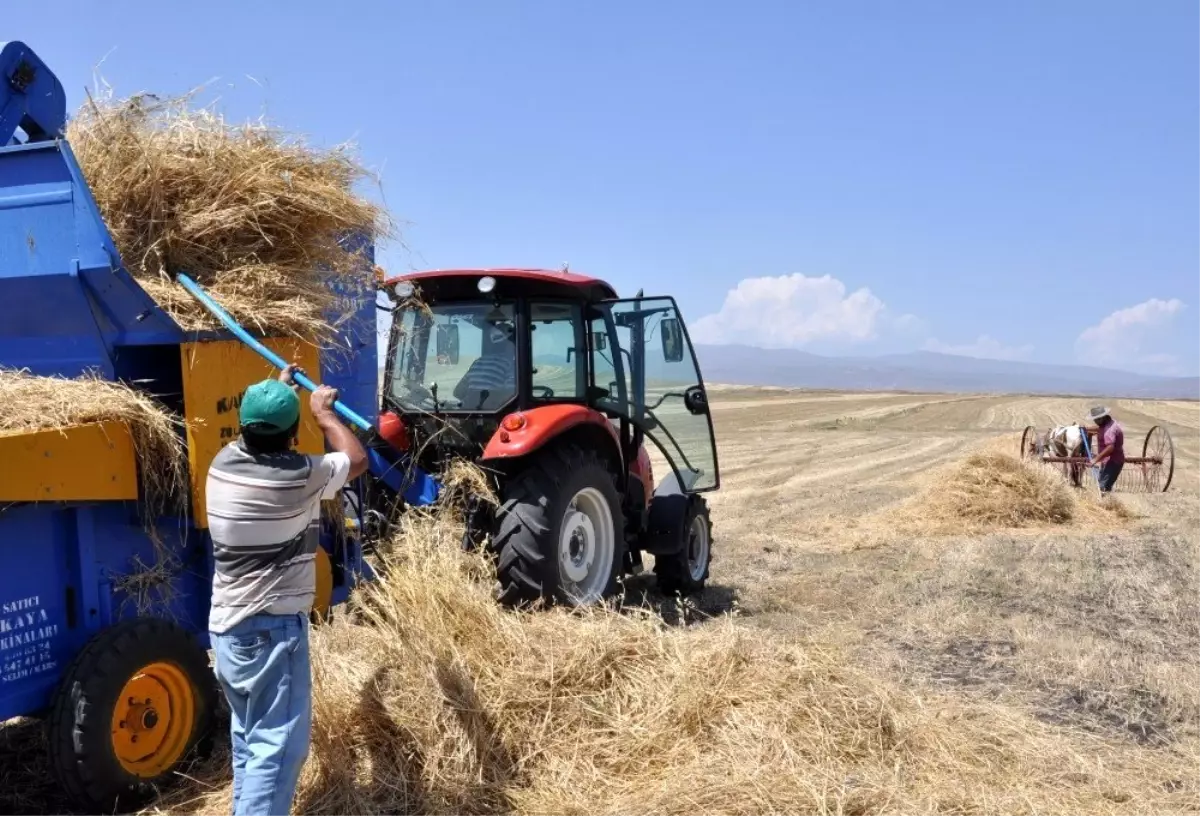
left=696, top=346, right=1200, bottom=400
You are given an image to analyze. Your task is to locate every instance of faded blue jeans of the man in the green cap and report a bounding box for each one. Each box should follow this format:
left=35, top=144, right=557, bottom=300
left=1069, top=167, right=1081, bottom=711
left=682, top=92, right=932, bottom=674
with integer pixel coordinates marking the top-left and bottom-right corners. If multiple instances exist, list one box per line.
left=210, top=614, right=312, bottom=816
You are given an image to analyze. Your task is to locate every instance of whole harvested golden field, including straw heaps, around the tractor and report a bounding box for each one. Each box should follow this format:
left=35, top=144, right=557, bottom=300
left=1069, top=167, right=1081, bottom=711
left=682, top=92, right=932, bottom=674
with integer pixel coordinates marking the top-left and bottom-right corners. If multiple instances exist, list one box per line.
left=0, top=389, right=1200, bottom=816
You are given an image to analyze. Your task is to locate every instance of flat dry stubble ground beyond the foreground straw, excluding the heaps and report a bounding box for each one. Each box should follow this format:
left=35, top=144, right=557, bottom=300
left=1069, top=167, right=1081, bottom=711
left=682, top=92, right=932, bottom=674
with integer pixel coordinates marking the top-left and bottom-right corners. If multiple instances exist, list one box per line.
left=0, top=388, right=1200, bottom=814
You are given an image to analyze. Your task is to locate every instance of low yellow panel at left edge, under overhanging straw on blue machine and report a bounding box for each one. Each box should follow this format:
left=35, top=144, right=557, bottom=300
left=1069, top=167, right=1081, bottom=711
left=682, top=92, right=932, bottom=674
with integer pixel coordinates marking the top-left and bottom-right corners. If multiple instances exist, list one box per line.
left=0, top=421, right=138, bottom=503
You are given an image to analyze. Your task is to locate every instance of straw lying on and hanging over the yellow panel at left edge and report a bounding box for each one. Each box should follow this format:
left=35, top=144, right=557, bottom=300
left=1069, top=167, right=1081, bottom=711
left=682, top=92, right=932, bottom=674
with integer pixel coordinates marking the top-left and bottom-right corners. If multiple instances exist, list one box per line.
left=0, top=368, right=187, bottom=508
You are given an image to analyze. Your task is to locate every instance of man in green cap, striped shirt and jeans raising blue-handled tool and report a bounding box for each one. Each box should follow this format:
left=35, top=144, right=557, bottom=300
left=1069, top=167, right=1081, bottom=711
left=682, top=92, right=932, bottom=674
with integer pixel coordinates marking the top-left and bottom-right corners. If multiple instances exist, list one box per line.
left=206, top=365, right=367, bottom=816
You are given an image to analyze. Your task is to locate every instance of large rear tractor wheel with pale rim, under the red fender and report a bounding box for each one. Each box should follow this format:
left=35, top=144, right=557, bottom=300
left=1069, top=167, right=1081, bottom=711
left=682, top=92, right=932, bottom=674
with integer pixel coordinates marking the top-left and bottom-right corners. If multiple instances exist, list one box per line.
left=493, top=446, right=625, bottom=606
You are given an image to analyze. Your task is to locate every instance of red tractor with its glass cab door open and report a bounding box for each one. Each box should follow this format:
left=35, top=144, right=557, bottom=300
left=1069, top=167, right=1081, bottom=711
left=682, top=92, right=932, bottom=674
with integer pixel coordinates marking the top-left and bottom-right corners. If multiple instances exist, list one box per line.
left=379, top=269, right=720, bottom=606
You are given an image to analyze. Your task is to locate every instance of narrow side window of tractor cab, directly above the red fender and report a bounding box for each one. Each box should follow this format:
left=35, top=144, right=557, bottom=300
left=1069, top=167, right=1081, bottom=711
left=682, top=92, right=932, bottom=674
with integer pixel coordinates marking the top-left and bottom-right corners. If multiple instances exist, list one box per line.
left=529, top=302, right=588, bottom=400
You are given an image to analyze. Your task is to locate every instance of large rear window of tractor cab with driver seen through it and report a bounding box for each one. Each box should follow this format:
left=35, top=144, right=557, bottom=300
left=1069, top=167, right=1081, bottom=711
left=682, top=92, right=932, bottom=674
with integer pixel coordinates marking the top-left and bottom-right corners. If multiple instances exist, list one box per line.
left=386, top=302, right=517, bottom=412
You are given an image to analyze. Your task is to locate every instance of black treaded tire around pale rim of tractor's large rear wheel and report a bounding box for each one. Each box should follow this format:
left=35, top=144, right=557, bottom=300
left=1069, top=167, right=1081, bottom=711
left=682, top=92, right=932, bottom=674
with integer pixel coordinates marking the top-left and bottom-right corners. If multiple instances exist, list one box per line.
left=492, top=445, right=626, bottom=606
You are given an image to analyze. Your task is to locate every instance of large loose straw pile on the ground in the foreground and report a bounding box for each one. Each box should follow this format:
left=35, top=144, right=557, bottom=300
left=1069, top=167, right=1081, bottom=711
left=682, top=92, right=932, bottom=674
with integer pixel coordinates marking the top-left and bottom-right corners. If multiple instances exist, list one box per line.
left=138, top=508, right=1194, bottom=816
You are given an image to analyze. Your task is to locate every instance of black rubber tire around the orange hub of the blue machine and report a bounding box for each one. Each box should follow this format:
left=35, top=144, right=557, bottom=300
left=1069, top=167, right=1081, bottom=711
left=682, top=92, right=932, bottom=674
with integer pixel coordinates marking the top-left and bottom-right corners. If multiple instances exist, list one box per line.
left=47, top=618, right=217, bottom=814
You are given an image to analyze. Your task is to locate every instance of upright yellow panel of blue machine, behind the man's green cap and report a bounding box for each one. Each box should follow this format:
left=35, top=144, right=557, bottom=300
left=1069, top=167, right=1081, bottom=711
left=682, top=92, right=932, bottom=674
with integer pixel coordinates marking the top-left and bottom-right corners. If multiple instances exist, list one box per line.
left=179, top=338, right=325, bottom=528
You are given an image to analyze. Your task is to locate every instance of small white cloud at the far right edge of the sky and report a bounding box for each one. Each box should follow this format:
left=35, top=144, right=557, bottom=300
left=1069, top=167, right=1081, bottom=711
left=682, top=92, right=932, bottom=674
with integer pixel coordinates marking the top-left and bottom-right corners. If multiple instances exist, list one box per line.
left=1075, top=298, right=1186, bottom=374
